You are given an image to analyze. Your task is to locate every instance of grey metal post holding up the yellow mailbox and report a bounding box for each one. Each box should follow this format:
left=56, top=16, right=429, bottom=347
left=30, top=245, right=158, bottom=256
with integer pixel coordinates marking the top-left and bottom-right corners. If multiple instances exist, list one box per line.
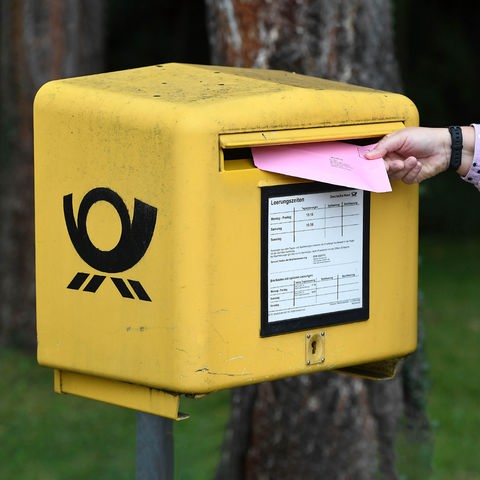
left=136, top=412, right=174, bottom=480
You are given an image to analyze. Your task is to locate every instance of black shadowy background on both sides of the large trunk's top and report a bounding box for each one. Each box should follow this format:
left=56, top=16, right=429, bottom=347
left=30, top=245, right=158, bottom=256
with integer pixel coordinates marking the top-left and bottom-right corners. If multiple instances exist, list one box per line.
left=106, top=0, right=480, bottom=236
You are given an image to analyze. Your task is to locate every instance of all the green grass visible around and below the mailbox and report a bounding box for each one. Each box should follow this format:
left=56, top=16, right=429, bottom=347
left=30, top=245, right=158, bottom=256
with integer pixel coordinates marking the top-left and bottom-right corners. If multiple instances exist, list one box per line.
left=0, top=234, right=480, bottom=480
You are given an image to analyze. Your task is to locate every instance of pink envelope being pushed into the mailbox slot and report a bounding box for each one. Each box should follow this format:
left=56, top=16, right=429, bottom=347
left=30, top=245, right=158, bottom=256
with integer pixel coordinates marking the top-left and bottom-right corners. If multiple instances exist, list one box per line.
left=252, top=142, right=392, bottom=192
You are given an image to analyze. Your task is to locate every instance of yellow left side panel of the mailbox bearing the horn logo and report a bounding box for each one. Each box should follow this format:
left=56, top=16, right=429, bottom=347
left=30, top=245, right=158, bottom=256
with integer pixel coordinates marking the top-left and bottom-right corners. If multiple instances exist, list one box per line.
left=35, top=82, right=196, bottom=385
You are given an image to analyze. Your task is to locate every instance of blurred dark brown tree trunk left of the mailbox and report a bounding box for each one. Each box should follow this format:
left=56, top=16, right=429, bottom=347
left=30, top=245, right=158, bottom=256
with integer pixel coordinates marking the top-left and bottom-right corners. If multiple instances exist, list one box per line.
left=0, top=0, right=103, bottom=348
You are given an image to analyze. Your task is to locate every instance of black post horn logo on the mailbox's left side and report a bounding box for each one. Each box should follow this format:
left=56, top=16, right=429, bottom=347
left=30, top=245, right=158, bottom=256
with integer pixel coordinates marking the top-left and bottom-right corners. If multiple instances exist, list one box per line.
left=63, top=187, right=157, bottom=302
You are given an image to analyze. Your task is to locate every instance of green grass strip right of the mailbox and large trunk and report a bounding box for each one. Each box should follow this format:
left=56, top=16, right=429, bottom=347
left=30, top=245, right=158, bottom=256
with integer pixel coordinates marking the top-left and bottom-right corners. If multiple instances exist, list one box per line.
left=419, top=238, right=480, bottom=480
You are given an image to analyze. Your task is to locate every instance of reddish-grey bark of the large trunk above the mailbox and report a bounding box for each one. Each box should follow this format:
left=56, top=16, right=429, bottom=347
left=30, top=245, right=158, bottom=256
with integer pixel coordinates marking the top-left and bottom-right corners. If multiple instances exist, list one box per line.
left=206, top=0, right=400, bottom=91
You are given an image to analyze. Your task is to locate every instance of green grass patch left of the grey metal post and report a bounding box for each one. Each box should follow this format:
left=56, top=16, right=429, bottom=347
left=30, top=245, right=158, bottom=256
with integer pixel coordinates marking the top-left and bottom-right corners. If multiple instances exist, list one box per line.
left=0, top=350, right=135, bottom=480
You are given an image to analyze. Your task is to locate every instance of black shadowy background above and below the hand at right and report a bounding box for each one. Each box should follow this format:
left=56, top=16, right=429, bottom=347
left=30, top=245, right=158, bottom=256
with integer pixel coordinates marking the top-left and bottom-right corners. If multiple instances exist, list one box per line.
left=395, top=0, right=480, bottom=236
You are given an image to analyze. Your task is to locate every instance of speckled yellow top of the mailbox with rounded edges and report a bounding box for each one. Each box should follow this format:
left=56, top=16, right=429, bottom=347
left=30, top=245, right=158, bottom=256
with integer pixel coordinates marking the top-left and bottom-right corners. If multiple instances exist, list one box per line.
left=36, top=63, right=418, bottom=134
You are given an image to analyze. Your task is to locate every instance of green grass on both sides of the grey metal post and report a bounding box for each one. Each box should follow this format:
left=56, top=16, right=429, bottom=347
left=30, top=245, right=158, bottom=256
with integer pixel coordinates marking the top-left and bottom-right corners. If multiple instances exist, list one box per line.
left=0, top=349, right=229, bottom=480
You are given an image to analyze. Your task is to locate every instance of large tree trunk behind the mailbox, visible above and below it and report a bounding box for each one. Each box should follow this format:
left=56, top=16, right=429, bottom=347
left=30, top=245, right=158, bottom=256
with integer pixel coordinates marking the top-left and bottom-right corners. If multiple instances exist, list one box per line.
left=206, top=0, right=426, bottom=480
